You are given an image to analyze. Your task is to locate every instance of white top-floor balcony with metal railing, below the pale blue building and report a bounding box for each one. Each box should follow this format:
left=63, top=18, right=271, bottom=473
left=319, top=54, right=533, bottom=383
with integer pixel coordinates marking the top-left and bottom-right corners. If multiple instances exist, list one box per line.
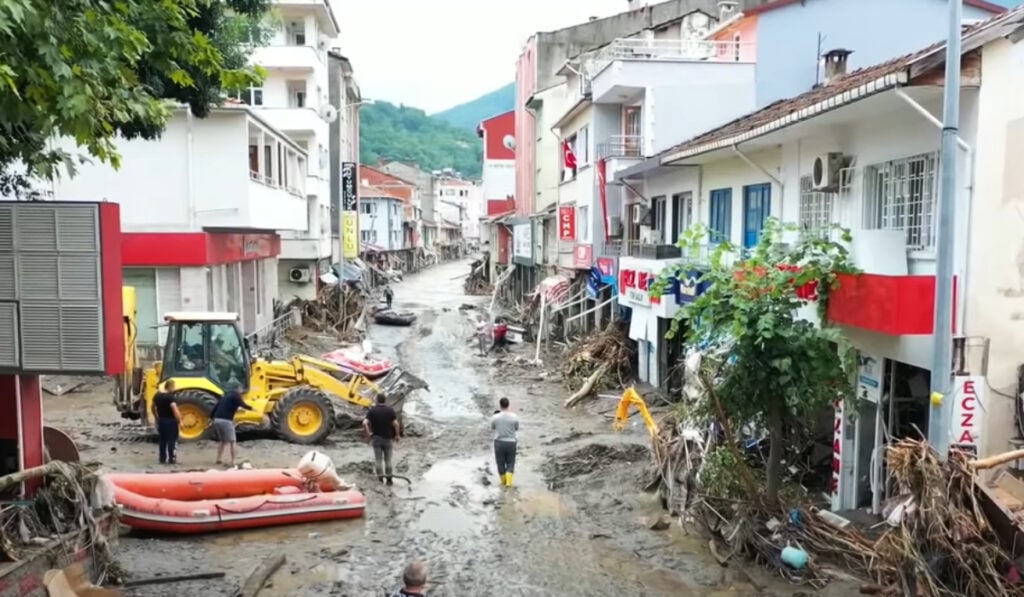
left=584, top=39, right=756, bottom=103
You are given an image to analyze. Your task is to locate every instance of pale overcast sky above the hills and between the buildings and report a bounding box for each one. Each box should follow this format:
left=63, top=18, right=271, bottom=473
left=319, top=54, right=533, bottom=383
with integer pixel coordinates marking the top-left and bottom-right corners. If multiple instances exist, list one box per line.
left=331, top=0, right=627, bottom=113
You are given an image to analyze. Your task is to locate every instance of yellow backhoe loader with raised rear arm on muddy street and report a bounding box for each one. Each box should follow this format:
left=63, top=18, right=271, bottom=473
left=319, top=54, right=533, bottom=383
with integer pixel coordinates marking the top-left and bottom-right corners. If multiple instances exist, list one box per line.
left=114, top=287, right=429, bottom=444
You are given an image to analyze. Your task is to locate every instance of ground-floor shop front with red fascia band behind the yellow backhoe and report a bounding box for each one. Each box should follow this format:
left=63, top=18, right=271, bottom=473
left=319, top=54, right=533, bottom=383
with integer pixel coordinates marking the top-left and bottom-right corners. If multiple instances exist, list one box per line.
left=121, top=230, right=281, bottom=345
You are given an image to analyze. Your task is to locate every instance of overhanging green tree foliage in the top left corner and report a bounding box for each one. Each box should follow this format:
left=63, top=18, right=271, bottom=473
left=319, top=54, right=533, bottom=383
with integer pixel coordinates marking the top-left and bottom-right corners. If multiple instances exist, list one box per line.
left=0, top=0, right=267, bottom=177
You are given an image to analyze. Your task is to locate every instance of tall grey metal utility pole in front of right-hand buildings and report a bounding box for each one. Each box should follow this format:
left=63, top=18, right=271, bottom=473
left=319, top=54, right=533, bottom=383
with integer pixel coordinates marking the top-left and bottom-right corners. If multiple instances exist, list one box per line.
left=928, top=0, right=964, bottom=458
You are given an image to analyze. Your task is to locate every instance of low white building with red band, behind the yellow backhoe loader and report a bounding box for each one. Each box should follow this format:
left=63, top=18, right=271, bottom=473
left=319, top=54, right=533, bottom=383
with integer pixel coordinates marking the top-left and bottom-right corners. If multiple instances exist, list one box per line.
left=53, top=105, right=307, bottom=344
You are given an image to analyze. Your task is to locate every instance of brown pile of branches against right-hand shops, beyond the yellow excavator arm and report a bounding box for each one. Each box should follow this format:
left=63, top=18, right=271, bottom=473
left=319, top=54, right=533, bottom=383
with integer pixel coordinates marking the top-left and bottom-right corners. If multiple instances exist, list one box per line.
left=561, top=319, right=634, bottom=407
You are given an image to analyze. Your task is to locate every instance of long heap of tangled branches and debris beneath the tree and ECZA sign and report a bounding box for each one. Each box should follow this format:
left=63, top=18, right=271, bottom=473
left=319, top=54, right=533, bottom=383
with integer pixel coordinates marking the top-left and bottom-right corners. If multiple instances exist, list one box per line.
left=651, top=422, right=1024, bottom=597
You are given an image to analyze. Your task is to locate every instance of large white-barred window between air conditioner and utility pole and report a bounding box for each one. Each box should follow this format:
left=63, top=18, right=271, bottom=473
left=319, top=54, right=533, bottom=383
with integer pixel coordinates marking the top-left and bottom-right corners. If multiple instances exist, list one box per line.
left=864, top=153, right=939, bottom=251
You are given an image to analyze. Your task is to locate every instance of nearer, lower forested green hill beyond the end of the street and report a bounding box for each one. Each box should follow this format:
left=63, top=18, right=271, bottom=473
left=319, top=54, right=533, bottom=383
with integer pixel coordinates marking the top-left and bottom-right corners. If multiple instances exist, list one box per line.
left=359, top=101, right=482, bottom=177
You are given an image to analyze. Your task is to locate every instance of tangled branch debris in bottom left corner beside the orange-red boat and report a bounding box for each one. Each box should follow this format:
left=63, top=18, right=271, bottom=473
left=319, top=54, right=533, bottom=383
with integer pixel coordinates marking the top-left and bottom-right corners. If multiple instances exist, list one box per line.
left=0, top=461, right=124, bottom=584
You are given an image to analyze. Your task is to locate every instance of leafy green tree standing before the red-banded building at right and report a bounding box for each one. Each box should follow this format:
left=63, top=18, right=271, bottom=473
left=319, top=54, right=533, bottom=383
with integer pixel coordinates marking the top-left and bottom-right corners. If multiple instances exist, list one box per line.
left=654, top=220, right=854, bottom=502
